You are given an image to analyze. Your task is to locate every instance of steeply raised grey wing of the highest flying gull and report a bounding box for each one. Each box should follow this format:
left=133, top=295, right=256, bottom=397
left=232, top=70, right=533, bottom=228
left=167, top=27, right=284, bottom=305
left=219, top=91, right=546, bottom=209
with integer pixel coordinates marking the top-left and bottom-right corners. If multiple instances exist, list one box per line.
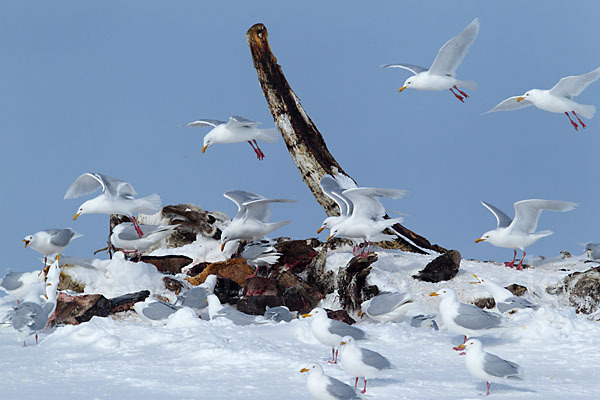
left=429, top=18, right=479, bottom=76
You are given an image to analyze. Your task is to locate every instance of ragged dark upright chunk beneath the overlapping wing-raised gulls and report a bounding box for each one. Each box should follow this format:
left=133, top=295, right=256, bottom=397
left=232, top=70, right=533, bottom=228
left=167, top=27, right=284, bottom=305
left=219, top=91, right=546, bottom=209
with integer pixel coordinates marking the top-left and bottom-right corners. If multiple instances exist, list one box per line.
left=338, top=254, right=378, bottom=311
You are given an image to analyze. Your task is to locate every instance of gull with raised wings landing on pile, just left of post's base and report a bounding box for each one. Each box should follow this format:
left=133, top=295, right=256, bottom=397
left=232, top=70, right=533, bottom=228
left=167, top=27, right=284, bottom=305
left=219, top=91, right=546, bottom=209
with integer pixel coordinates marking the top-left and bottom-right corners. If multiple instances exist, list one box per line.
left=221, top=190, right=295, bottom=251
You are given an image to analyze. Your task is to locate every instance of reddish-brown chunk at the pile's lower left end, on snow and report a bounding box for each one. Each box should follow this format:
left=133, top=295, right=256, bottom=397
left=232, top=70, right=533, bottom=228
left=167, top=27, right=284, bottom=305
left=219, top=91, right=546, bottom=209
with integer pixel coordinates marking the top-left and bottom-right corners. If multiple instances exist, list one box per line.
left=48, top=292, right=112, bottom=327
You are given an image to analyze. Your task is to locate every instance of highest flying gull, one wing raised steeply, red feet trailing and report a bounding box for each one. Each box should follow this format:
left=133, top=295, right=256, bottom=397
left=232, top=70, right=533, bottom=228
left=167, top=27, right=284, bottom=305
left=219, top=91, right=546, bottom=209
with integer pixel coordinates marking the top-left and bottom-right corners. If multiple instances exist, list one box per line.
left=382, top=18, right=479, bottom=103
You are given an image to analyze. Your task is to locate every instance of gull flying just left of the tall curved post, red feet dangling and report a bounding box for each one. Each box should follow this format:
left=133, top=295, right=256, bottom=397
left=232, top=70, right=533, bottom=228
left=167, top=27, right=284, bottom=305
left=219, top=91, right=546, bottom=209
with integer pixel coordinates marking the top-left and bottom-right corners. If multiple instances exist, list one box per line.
left=184, top=116, right=279, bottom=160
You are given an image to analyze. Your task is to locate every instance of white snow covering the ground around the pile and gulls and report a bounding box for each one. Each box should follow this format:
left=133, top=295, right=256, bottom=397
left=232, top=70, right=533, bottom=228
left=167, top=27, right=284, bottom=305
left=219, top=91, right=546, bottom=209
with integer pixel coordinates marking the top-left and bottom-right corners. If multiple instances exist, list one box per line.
left=0, top=244, right=600, bottom=399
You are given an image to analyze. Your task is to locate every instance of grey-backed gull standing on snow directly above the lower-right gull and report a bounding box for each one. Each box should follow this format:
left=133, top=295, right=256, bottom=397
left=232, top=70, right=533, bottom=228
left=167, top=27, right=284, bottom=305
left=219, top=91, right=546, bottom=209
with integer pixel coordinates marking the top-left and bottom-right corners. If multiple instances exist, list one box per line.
left=429, top=288, right=502, bottom=342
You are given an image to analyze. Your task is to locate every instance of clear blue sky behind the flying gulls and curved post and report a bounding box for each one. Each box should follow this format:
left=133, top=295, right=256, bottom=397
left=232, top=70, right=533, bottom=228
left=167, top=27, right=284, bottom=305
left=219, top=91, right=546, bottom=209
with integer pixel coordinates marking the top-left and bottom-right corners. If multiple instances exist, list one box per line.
left=0, top=0, right=600, bottom=273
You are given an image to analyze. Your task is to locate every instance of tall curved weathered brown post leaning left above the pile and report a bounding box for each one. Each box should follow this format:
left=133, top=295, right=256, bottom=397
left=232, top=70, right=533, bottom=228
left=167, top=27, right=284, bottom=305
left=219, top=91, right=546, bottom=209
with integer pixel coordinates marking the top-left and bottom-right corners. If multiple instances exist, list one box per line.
left=246, top=24, right=445, bottom=253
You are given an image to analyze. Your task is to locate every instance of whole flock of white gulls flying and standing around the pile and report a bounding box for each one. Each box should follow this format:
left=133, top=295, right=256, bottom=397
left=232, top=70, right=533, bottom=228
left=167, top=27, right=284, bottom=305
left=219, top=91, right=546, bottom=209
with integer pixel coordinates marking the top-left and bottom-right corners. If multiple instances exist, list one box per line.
left=0, top=14, right=600, bottom=399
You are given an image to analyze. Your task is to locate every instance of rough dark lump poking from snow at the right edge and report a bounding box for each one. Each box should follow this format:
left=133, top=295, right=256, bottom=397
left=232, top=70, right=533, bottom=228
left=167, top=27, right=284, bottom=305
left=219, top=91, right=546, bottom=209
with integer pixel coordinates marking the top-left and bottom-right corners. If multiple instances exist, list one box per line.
left=546, top=267, right=600, bottom=314
